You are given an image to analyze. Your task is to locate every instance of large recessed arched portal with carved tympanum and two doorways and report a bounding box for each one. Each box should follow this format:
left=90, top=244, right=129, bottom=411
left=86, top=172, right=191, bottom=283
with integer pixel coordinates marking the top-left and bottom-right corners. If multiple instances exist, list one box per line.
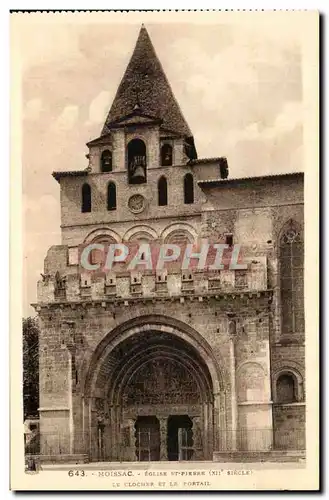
left=85, top=328, right=218, bottom=461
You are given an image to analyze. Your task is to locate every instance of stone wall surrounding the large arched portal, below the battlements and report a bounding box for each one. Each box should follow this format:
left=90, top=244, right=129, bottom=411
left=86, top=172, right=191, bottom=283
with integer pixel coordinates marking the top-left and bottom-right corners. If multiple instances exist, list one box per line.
left=39, top=290, right=270, bottom=453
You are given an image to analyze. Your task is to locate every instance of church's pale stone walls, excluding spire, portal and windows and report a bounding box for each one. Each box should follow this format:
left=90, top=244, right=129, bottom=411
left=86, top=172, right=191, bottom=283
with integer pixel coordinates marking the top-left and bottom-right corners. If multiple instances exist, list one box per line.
left=38, top=158, right=305, bottom=456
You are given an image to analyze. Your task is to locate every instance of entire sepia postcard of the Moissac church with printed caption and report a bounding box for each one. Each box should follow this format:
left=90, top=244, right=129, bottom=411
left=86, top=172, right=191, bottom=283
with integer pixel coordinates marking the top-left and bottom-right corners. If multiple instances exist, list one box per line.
left=10, top=11, right=319, bottom=491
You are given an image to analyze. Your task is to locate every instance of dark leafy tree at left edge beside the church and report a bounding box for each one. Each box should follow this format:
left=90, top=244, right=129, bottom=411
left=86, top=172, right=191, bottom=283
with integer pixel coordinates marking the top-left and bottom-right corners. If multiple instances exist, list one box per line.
left=23, top=317, right=39, bottom=420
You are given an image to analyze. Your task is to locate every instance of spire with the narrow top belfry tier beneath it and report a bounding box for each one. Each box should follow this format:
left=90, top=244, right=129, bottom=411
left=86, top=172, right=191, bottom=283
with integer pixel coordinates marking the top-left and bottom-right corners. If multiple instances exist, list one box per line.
left=87, top=25, right=197, bottom=180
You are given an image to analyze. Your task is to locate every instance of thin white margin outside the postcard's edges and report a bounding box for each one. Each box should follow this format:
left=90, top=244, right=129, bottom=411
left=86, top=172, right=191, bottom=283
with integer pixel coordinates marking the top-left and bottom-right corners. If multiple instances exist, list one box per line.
left=4, top=0, right=322, bottom=498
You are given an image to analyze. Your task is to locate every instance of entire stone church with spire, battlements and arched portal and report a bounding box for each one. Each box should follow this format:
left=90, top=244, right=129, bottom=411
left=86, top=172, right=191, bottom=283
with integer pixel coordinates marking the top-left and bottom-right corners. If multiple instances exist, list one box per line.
left=34, top=26, right=305, bottom=462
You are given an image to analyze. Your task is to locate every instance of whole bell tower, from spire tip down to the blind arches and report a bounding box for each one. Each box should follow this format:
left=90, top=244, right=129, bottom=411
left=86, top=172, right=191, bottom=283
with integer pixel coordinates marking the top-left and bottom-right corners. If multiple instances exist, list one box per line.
left=53, top=25, right=227, bottom=248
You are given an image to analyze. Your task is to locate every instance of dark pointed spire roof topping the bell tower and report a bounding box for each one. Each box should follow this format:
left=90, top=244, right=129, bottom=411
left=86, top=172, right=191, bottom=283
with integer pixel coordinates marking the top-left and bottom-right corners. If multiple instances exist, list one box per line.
left=102, top=25, right=193, bottom=143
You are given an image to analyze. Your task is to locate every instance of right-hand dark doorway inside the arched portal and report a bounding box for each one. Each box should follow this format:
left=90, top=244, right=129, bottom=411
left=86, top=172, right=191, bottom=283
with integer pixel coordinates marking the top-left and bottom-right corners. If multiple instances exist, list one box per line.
left=167, top=415, right=194, bottom=461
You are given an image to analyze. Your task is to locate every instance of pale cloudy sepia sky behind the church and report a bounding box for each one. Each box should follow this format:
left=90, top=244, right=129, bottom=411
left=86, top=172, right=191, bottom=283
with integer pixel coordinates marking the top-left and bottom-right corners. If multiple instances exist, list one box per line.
left=15, top=15, right=303, bottom=316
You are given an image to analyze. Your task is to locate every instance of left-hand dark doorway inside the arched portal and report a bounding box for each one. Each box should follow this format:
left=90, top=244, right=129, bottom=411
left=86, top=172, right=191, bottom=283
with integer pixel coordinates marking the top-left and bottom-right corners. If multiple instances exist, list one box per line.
left=135, top=416, right=160, bottom=462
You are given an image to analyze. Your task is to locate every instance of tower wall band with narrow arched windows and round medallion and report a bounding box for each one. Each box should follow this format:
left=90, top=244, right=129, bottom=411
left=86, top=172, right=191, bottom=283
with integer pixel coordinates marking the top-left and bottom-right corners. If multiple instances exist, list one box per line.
left=61, top=166, right=203, bottom=232
